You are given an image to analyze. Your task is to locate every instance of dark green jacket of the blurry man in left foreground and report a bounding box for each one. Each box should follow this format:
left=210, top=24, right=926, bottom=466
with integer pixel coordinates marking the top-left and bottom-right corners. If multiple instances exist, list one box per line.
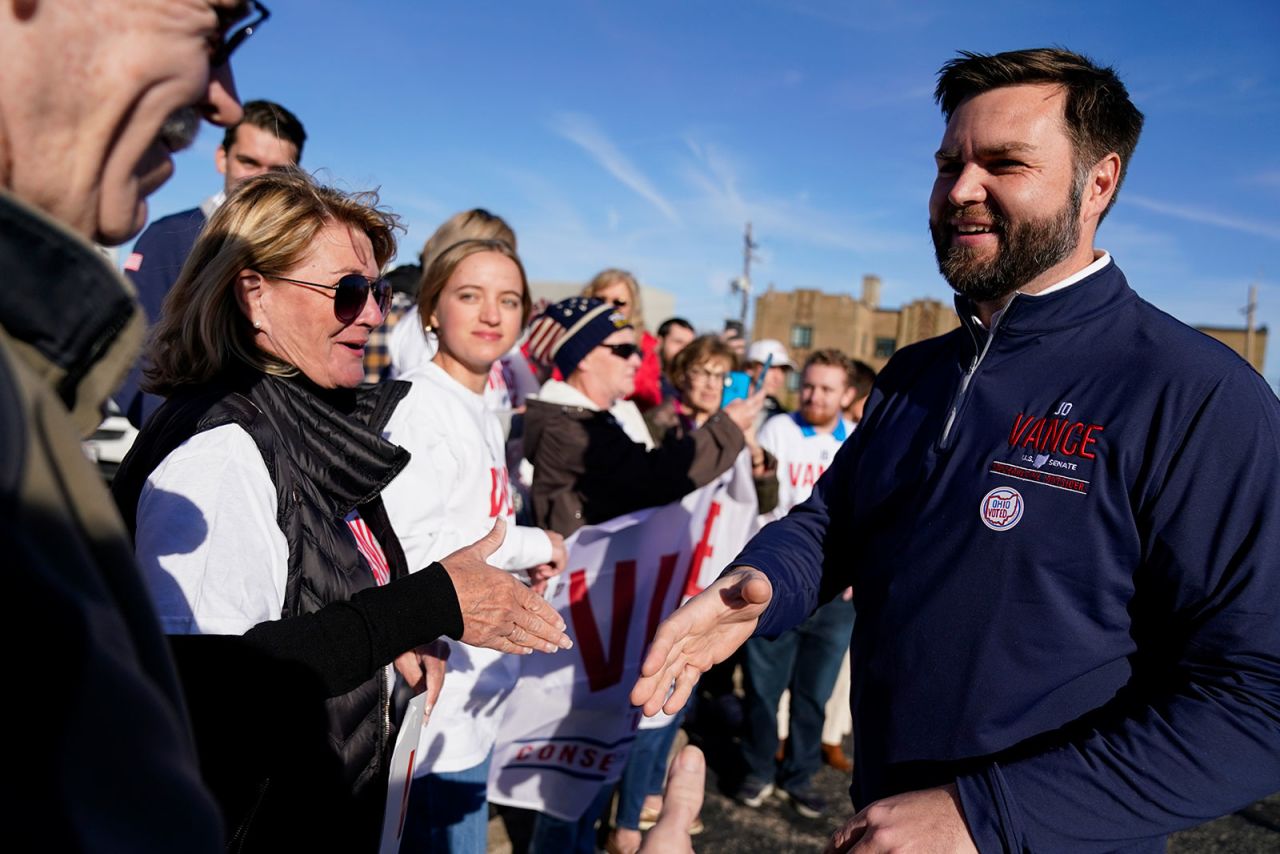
left=0, top=192, right=221, bottom=851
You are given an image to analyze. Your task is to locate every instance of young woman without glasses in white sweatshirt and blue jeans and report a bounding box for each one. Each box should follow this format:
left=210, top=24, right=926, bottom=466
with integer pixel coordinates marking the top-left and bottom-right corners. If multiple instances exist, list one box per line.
left=373, top=239, right=564, bottom=854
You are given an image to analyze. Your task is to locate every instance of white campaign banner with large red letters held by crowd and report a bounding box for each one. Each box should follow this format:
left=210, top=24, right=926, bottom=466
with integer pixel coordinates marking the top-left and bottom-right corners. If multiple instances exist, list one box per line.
left=489, top=452, right=756, bottom=821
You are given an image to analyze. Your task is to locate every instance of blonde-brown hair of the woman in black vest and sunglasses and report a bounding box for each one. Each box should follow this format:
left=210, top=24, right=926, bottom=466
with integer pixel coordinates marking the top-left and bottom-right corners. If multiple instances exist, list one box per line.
left=145, top=169, right=399, bottom=394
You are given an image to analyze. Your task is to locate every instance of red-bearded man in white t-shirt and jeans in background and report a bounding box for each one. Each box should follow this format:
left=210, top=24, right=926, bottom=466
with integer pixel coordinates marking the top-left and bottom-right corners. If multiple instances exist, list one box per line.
left=737, top=350, right=855, bottom=818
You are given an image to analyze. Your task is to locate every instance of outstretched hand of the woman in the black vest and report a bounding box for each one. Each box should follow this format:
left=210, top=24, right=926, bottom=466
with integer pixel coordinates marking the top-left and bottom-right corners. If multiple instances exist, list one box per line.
left=440, top=519, right=573, bottom=654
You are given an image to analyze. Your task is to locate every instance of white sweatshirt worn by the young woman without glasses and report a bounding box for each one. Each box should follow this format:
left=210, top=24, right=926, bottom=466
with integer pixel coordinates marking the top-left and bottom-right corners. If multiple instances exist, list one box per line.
left=383, top=362, right=552, bottom=775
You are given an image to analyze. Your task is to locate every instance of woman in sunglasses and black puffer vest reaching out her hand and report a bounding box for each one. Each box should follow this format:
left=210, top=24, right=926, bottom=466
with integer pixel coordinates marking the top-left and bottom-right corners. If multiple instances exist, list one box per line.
left=106, top=172, right=567, bottom=851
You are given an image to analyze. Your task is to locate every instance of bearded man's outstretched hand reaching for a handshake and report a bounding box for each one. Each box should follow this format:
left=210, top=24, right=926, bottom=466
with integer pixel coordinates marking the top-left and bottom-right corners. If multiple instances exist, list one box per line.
left=631, top=566, right=773, bottom=717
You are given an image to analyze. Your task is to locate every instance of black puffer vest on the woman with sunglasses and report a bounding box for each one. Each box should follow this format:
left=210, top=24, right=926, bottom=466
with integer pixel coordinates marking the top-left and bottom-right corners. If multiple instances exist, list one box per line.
left=113, top=374, right=408, bottom=845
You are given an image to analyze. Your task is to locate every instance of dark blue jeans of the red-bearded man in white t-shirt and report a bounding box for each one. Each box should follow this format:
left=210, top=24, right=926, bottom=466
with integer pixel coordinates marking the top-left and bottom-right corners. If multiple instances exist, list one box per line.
left=742, top=599, right=854, bottom=790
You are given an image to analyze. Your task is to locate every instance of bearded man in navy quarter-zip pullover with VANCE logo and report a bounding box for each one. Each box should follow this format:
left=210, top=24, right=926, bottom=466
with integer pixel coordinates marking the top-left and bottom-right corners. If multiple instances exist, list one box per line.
left=632, top=49, right=1280, bottom=851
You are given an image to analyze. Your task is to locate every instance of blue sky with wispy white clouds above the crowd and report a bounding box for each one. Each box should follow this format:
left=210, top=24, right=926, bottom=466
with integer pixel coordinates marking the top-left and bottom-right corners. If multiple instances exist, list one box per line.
left=142, top=0, right=1280, bottom=387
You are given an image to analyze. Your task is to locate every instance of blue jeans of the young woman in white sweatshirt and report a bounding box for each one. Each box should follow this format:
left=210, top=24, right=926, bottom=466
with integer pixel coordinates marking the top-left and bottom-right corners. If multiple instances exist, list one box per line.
left=401, top=752, right=493, bottom=854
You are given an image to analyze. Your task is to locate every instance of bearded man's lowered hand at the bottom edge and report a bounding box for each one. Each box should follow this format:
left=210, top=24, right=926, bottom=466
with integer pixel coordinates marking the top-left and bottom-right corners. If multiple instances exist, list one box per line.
left=826, top=785, right=978, bottom=854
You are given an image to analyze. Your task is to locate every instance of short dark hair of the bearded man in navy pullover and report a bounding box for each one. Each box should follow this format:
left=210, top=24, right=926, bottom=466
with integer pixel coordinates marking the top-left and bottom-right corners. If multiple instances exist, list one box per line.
left=933, top=47, right=1143, bottom=216
